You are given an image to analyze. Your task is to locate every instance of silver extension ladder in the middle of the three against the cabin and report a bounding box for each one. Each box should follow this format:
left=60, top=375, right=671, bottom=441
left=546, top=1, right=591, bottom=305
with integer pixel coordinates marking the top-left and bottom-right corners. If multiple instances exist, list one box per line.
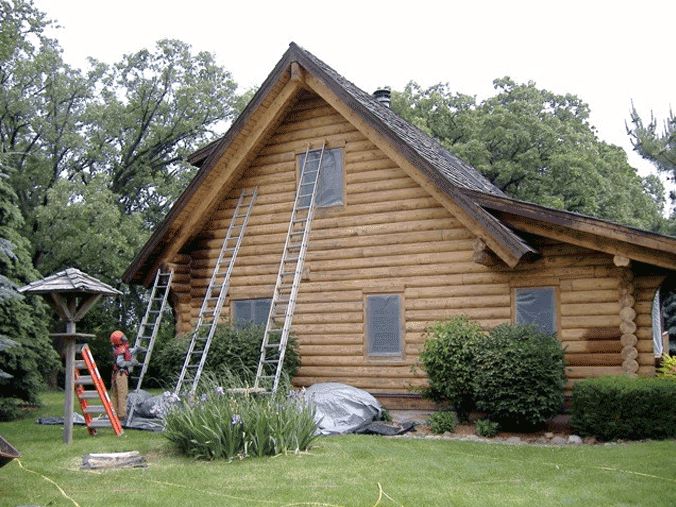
left=174, top=188, right=257, bottom=394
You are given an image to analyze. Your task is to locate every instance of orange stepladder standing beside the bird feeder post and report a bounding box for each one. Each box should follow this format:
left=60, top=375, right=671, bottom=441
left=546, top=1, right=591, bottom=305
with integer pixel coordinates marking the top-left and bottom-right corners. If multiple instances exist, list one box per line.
left=75, top=343, right=122, bottom=437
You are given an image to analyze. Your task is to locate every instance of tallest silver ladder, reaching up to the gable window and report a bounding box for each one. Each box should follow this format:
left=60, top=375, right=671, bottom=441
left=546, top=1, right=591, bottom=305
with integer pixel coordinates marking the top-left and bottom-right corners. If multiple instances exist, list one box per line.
left=253, top=143, right=326, bottom=393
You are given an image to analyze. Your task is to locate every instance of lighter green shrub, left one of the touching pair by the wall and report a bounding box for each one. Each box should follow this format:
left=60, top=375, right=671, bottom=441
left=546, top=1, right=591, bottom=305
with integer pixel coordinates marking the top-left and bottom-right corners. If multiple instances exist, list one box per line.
left=420, top=315, right=485, bottom=417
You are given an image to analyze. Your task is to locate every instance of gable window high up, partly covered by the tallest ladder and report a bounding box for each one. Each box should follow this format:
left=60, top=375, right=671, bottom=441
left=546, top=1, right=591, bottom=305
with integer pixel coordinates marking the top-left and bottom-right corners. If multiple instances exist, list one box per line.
left=299, top=149, right=345, bottom=208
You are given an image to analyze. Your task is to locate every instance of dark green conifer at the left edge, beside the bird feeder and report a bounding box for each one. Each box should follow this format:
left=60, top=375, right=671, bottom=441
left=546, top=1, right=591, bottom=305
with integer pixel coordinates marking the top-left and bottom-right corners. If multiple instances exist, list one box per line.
left=0, top=157, right=58, bottom=420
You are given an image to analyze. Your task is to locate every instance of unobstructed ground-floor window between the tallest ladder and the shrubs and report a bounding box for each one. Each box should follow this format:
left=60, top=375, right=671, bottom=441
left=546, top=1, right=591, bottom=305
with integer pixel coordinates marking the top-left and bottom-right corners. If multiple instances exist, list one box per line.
left=366, top=294, right=403, bottom=356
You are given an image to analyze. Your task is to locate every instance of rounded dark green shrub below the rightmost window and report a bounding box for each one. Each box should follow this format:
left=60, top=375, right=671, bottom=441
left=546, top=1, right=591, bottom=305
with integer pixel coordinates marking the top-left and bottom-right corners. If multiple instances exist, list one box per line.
left=472, top=324, right=566, bottom=428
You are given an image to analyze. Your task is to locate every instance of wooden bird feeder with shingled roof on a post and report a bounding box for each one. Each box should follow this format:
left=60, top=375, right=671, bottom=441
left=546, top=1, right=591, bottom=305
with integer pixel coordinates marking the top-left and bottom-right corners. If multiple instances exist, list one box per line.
left=19, top=268, right=122, bottom=444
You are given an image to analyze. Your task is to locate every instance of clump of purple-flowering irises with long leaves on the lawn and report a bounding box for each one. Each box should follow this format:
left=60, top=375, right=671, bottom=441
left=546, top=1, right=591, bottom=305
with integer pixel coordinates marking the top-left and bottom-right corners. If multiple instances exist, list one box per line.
left=164, top=380, right=317, bottom=460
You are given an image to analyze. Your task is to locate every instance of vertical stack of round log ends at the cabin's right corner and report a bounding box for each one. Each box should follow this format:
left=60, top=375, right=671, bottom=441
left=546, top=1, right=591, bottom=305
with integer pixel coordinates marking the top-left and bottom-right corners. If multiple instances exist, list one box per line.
left=613, top=268, right=639, bottom=376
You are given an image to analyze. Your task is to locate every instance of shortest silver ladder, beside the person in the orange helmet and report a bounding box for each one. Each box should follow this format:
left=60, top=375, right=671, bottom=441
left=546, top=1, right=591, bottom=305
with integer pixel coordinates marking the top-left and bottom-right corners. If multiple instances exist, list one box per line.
left=127, top=269, right=174, bottom=423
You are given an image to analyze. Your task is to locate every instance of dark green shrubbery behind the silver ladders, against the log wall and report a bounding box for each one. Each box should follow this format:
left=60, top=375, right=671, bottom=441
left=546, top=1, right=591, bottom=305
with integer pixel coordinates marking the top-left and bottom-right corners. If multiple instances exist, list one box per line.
left=150, top=324, right=300, bottom=386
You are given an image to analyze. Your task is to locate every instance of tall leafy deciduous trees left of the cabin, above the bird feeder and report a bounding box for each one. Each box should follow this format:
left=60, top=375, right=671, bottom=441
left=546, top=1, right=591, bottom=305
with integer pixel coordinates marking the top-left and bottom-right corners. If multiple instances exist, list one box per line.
left=0, top=0, right=242, bottom=350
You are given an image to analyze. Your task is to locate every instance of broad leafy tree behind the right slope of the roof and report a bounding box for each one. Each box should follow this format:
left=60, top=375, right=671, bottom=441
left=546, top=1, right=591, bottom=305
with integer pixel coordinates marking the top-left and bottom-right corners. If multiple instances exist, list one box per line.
left=392, top=77, right=663, bottom=230
